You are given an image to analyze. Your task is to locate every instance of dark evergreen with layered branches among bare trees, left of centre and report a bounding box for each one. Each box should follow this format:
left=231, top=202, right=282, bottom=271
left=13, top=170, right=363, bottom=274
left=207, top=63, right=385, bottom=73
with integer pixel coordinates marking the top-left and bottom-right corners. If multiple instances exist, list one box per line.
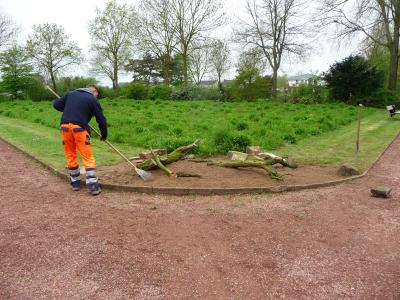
left=125, top=53, right=162, bottom=83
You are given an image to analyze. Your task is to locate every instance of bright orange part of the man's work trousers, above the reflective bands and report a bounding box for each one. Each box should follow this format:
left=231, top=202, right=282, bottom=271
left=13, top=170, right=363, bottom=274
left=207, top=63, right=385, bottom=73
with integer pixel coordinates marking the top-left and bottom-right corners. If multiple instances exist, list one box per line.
left=61, top=123, right=96, bottom=169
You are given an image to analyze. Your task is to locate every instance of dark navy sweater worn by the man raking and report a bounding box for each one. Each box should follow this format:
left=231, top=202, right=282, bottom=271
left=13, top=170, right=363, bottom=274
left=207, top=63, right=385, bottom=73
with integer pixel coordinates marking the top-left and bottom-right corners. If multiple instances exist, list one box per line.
left=53, top=89, right=107, bottom=138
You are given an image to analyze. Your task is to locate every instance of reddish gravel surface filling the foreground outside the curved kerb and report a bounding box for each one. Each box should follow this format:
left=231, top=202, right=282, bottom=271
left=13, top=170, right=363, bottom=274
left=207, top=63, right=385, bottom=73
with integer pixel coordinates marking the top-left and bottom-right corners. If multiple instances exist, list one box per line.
left=0, top=138, right=400, bottom=300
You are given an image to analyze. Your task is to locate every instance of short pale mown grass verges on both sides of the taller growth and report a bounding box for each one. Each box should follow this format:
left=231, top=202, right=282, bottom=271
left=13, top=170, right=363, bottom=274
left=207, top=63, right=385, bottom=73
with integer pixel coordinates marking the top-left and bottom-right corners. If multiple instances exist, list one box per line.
left=0, top=110, right=400, bottom=171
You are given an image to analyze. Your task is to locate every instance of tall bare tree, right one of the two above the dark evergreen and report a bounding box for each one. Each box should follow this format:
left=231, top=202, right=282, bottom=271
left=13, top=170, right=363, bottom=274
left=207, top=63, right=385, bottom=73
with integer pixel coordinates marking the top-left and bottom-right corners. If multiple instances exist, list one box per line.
left=171, top=0, right=223, bottom=84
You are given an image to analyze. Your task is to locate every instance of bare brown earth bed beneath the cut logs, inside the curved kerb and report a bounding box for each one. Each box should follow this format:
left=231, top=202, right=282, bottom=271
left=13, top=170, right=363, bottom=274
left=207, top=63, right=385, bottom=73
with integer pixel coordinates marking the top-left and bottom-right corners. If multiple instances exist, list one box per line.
left=99, top=157, right=344, bottom=189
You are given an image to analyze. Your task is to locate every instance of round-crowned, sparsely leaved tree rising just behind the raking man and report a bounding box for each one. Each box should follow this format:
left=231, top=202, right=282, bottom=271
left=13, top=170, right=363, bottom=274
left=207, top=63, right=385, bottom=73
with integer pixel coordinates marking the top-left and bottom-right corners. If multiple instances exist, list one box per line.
left=26, top=23, right=82, bottom=92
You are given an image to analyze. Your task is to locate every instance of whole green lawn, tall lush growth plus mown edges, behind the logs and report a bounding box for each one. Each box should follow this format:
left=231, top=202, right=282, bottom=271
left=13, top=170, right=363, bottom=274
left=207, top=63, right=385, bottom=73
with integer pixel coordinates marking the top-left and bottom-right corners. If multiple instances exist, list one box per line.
left=0, top=100, right=400, bottom=170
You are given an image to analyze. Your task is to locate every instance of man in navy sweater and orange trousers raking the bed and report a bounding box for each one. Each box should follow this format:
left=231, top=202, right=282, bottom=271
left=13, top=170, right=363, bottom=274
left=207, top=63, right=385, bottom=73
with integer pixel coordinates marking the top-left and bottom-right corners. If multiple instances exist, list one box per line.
left=53, top=84, right=107, bottom=196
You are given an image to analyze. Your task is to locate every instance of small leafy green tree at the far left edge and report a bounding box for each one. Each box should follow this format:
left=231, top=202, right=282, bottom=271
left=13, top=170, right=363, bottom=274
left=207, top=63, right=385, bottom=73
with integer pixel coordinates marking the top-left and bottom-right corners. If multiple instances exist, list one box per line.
left=0, top=45, right=34, bottom=98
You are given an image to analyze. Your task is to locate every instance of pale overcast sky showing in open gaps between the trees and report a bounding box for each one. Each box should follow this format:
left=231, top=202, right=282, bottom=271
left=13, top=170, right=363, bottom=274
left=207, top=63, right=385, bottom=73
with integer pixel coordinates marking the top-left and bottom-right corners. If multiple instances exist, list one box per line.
left=0, top=0, right=357, bottom=85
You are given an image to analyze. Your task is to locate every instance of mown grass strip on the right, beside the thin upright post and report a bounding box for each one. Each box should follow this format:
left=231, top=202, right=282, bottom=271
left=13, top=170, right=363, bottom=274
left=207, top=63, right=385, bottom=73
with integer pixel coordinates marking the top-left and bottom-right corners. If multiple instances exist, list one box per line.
left=278, top=110, right=400, bottom=171
